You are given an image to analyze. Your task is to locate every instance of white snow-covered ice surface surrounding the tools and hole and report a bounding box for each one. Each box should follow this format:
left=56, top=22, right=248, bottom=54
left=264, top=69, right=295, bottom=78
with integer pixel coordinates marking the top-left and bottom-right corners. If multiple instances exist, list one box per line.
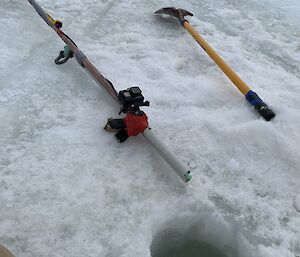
left=0, top=0, right=300, bottom=257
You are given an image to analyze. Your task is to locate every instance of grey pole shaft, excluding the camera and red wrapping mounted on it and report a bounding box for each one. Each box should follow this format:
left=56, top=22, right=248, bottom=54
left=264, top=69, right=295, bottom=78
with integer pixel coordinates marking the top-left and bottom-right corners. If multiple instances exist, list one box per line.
left=28, top=0, right=192, bottom=182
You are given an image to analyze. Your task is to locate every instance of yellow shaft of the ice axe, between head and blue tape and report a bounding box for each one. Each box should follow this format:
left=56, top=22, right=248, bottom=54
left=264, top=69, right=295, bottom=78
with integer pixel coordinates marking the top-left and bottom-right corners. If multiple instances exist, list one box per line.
left=183, top=21, right=251, bottom=95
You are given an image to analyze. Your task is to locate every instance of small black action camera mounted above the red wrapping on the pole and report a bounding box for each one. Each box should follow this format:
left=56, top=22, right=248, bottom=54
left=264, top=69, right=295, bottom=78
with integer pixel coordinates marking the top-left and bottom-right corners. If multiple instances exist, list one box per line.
left=118, top=87, right=150, bottom=113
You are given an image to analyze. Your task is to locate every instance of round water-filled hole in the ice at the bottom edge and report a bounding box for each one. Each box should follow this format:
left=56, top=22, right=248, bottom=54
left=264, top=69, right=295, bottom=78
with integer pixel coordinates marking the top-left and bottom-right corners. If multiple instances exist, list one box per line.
left=150, top=216, right=252, bottom=257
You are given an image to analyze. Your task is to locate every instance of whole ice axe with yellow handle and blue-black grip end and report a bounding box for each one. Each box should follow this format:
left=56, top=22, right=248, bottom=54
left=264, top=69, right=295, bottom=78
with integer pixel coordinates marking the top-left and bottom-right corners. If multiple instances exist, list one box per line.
left=155, top=7, right=275, bottom=121
